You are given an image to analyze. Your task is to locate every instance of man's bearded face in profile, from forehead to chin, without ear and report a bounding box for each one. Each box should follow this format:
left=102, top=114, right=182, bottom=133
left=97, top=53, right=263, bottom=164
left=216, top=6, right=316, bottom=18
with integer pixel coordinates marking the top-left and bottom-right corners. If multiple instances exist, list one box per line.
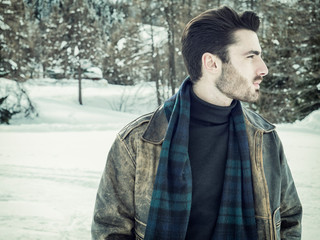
left=216, top=29, right=268, bottom=102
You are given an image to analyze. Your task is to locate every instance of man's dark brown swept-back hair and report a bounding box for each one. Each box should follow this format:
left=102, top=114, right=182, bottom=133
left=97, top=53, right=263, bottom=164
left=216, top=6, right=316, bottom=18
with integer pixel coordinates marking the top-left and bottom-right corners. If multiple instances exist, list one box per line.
left=181, top=7, right=260, bottom=82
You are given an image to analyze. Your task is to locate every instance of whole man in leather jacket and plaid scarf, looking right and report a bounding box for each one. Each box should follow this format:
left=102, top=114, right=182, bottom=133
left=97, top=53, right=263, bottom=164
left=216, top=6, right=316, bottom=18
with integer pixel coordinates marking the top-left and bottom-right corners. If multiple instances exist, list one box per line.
left=92, top=7, right=302, bottom=240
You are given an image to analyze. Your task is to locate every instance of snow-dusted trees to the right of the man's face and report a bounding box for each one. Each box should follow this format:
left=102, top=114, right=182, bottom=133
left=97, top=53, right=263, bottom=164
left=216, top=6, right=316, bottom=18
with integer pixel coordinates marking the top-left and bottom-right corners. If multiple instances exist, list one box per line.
left=251, top=1, right=320, bottom=123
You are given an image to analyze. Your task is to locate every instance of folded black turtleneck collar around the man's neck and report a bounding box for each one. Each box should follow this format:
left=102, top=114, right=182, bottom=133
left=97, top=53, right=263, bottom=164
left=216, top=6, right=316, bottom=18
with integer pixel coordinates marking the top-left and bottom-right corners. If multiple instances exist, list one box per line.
left=190, top=88, right=236, bottom=125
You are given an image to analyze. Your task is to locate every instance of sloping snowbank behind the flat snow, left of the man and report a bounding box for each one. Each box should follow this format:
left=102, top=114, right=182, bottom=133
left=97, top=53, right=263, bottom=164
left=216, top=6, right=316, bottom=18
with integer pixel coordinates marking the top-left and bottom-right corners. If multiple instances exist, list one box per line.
left=0, top=79, right=157, bottom=131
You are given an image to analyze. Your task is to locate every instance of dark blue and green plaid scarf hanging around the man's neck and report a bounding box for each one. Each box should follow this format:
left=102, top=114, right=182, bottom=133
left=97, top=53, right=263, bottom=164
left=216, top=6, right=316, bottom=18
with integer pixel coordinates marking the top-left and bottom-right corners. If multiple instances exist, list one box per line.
left=145, top=78, right=257, bottom=240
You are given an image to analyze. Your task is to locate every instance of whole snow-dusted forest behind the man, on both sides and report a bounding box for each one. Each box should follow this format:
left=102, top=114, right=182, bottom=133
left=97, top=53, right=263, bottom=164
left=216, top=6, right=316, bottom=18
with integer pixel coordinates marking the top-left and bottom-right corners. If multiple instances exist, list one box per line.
left=0, top=0, right=320, bottom=123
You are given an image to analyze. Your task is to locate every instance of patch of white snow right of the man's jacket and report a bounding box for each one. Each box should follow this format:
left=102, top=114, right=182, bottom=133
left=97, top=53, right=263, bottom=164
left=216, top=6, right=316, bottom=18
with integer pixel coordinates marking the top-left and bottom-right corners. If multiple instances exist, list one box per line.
left=278, top=124, right=320, bottom=239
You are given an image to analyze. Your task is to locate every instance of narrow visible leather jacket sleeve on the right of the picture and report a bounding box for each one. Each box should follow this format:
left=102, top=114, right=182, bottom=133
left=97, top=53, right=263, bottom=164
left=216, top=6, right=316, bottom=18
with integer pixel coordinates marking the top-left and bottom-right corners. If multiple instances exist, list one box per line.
left=280, top=136, right=302, bottom=240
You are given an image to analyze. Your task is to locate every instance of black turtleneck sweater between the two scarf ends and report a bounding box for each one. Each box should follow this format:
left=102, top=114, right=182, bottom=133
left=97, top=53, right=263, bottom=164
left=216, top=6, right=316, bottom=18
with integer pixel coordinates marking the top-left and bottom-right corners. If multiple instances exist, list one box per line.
left=186, top=90, right=235, bottom=240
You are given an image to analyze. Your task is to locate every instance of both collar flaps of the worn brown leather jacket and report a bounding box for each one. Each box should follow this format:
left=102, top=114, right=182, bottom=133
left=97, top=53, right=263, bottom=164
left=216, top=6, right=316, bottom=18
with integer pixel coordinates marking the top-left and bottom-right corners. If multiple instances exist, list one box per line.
left=142, top=101, right=275, bottom=144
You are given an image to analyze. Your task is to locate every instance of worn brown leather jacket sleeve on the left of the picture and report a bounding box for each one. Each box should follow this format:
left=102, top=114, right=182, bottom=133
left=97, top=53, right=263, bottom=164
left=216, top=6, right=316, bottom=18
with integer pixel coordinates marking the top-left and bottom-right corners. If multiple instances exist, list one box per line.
left=91, top=136, right=135, bottom=240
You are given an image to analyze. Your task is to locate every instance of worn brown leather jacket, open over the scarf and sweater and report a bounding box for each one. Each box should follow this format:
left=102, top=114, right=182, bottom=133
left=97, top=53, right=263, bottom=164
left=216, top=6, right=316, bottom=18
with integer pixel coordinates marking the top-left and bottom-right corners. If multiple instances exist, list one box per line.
left=91, top=107, right=302, bottom=240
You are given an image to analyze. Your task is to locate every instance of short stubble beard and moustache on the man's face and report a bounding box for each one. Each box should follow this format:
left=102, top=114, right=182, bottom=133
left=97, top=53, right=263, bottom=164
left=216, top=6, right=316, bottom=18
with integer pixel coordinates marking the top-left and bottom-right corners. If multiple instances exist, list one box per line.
left=216, top=63, right=262, bottom=103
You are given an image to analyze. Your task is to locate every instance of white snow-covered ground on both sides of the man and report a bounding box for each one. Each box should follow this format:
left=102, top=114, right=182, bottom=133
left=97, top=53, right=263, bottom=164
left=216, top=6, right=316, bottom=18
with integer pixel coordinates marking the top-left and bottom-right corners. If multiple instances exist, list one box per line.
left=0, top=79, right=320, bottom=240
